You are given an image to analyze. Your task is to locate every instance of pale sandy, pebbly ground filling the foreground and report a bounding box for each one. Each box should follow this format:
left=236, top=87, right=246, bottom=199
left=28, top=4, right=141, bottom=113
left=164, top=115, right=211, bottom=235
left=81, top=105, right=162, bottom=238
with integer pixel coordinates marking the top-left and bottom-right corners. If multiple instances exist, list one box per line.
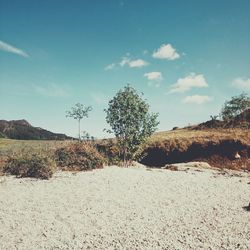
left=0, top=167, right=250, bottom=250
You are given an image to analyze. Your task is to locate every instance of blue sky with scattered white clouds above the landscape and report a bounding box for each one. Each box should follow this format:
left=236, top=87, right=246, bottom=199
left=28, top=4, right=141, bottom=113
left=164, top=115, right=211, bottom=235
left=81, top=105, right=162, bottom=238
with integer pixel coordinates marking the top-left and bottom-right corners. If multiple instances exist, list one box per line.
left=0, top=0, right=250, bottom=138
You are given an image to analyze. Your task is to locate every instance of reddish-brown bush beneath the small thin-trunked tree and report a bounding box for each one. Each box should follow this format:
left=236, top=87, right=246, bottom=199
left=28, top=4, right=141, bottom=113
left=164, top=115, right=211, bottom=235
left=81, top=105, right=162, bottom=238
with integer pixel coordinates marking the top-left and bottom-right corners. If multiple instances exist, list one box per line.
left=55, top=142, right=105, bottom=171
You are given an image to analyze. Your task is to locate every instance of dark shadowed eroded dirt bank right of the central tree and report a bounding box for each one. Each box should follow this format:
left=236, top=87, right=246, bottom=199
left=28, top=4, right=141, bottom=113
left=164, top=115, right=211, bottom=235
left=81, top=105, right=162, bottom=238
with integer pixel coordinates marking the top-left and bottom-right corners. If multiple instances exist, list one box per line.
left=141, top=139, right=250, bottom=170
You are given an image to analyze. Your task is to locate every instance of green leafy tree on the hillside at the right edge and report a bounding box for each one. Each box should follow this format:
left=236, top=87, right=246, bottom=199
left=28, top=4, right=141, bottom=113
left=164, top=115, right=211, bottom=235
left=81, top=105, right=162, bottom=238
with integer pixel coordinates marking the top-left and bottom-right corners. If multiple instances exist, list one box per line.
left=221, top=93, right=250, bottom=121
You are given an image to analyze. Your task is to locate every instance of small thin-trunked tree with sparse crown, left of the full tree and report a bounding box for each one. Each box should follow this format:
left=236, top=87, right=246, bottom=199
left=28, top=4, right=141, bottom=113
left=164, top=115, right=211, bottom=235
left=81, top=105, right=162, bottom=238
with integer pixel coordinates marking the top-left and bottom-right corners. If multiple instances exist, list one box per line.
left=66, top=103, right=92, bottom=141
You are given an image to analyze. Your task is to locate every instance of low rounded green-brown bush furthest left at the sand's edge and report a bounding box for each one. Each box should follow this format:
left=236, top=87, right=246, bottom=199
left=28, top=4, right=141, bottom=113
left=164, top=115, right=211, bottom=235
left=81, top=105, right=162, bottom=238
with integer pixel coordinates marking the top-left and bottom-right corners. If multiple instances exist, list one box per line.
left=3, top=152, right=56, bottom=179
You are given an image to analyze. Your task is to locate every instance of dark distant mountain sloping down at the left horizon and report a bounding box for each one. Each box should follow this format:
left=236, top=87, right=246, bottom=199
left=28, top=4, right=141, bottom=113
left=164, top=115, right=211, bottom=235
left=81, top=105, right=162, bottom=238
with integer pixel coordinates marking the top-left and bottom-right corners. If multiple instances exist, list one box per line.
left=0, top=120, right=72, bottom=140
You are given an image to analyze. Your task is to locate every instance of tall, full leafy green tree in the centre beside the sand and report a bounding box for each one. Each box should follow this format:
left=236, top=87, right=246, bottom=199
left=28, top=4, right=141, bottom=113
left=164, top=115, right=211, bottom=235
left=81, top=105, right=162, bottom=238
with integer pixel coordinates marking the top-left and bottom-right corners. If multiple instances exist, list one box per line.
left=104, top=86, right=159, bottom=166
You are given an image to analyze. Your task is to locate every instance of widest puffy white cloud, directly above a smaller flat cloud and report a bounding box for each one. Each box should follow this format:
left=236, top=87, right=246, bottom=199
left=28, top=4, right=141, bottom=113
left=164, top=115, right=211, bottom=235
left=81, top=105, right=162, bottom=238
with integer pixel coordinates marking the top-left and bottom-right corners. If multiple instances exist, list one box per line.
left=169, top=73, right=208, bottom=93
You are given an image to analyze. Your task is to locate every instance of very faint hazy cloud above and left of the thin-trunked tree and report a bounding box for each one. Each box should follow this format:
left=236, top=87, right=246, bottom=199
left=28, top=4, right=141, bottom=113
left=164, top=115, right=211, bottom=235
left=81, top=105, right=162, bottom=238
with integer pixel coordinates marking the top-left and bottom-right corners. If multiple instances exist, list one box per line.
left=33, top=83, right=68, bottom=97
